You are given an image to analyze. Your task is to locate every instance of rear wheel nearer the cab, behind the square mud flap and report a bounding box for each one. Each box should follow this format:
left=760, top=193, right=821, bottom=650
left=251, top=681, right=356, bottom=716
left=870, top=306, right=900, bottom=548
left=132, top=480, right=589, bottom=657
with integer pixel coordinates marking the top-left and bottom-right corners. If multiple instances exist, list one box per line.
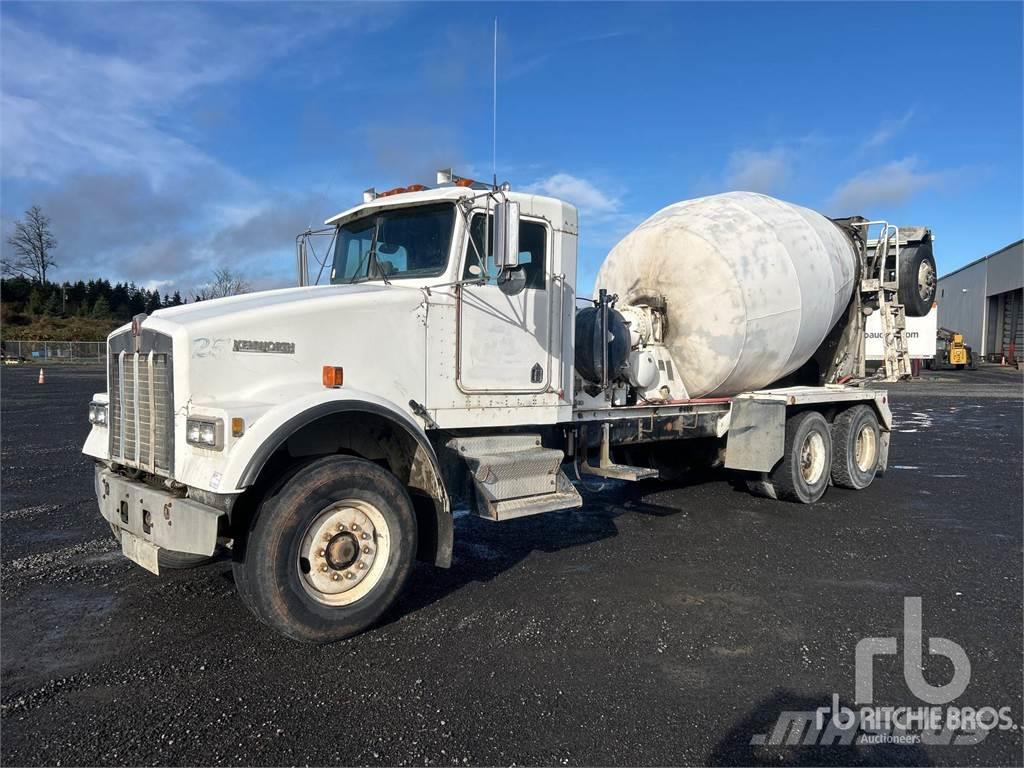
left=755, top=411, right=833, bottom=504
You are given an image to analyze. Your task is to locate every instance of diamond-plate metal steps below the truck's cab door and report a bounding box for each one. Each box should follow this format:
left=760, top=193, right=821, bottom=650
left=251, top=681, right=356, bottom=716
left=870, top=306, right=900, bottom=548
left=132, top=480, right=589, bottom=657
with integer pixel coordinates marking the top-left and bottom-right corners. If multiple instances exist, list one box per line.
left=447, top=434, right=583, bottom=520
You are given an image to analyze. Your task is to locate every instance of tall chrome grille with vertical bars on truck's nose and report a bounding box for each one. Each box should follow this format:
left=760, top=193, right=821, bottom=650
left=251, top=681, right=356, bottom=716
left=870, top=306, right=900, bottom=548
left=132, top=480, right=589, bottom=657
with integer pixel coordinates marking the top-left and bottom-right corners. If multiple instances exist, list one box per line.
left=109, top=334, right=174, bottom=476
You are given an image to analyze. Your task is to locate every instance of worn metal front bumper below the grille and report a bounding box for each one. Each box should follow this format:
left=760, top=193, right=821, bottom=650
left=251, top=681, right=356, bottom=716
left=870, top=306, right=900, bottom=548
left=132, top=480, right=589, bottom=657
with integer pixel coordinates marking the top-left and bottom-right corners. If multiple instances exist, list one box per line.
left=95, top=465, right=224, bottom=555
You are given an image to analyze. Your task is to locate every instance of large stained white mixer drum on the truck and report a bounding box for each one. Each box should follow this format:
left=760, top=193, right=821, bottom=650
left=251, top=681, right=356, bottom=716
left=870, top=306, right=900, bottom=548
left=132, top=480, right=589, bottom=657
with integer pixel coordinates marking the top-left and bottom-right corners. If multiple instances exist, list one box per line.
left=596, top=191, right=857, bottom=397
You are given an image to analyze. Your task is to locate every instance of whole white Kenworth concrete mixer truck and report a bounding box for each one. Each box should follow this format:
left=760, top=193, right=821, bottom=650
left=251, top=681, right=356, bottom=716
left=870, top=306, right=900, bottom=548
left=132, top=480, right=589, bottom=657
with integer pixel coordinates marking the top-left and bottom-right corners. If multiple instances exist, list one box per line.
left=84, top=172, right=935, bottom=642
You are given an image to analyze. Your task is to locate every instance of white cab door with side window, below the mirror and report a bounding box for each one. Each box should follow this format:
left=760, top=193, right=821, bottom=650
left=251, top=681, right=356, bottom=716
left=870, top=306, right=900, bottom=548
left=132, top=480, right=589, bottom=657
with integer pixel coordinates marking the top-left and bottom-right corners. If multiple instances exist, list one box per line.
left=456, top=213, right=553, bottom=394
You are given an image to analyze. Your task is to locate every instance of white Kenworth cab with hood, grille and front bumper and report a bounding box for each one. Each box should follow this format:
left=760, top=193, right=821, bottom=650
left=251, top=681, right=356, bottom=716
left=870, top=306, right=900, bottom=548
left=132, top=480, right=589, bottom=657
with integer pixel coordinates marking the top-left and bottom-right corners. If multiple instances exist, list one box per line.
left=84, top=174, right=593, bottom=639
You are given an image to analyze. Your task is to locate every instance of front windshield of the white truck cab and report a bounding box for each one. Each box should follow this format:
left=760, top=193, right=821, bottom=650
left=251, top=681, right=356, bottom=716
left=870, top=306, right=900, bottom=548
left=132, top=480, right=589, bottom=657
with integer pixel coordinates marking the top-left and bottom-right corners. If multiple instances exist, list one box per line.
left=331, top=203, right=455, bottom=285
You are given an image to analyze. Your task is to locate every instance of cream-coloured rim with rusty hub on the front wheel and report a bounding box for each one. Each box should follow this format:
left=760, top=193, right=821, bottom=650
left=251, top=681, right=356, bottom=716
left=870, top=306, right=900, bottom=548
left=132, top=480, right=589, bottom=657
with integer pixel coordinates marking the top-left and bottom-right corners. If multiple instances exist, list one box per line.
left=297, top=499, right=391, bottom=606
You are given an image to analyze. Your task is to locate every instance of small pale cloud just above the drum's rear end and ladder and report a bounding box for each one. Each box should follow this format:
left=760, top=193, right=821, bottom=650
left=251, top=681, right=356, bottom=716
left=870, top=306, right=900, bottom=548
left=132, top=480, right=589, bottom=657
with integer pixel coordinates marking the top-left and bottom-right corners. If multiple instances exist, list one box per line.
left=827, top=157, right=961, bottom=215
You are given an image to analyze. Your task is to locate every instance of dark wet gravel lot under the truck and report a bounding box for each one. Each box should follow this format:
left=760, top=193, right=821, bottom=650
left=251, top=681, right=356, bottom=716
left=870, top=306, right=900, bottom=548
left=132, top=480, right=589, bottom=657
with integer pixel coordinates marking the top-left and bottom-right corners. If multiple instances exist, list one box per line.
left=0, top=367, right=1024, bottom=765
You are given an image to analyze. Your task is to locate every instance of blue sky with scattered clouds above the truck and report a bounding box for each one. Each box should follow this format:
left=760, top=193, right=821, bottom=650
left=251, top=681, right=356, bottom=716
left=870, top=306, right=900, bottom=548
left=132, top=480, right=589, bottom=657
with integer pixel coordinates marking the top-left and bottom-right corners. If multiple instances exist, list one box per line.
left=0, top=2, right=1024, bottom=293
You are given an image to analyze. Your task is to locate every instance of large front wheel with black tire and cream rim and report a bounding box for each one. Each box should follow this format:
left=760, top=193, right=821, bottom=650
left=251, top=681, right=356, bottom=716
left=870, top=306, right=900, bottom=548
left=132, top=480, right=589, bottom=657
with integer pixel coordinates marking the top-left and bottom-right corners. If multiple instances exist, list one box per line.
left=233, top=456, right=417, bottom=643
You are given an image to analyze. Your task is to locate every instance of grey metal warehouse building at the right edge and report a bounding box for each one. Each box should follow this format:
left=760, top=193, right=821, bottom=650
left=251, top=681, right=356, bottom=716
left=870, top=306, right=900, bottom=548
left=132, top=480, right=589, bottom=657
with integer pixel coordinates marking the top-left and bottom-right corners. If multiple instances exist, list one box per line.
left=937, top=240, right=1024, bottom=360
